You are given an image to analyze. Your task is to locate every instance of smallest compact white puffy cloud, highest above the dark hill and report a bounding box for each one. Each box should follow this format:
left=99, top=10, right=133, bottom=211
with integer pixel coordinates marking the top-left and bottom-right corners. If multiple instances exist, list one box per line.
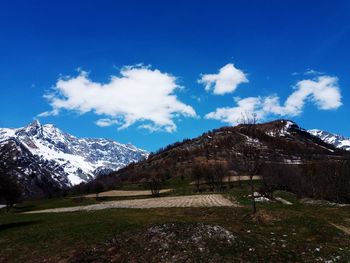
left=198, top=64, right=248, bottom=95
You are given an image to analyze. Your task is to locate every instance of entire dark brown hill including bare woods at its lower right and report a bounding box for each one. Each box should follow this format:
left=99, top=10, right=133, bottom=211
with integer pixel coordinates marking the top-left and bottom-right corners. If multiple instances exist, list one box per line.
left=98, top=120, right=350, bottom=203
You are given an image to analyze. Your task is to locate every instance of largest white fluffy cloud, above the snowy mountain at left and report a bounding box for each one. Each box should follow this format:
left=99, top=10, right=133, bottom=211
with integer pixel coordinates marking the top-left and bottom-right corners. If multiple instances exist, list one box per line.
left=40, top=66, right=196, bottom=132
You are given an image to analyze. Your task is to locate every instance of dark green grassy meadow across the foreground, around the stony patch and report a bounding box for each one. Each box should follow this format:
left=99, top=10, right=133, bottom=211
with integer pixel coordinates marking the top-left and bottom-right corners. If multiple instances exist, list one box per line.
left=0, top=179, right=350, bottom=262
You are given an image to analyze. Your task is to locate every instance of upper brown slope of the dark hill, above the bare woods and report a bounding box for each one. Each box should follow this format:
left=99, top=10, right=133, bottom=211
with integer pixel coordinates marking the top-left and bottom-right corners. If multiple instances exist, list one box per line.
left=110, top=120, right=348, bottom=184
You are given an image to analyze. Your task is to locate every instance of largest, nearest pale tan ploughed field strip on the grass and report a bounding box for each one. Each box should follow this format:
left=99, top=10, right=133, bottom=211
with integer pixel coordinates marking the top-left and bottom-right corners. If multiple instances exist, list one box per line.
left=26, top=194, right=238, bottom=214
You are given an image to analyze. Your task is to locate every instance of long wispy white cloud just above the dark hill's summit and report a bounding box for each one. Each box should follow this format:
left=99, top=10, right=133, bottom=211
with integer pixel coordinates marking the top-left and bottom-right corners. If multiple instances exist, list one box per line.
left=205, top=76, right=342, bottom=125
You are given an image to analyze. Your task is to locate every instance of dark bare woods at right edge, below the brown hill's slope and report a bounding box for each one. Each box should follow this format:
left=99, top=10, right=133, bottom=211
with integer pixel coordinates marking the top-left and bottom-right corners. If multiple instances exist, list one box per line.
left=261, top=160, right=350, bottom=203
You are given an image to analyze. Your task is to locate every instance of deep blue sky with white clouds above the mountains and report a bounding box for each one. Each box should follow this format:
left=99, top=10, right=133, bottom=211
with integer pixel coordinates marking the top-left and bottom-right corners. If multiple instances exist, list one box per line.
left=0, top=0, right=350, bottom=151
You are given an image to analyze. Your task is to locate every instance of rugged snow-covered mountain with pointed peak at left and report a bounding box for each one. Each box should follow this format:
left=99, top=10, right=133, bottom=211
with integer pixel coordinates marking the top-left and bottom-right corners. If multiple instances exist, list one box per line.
left=0, top=121, right=148, bottom=197
